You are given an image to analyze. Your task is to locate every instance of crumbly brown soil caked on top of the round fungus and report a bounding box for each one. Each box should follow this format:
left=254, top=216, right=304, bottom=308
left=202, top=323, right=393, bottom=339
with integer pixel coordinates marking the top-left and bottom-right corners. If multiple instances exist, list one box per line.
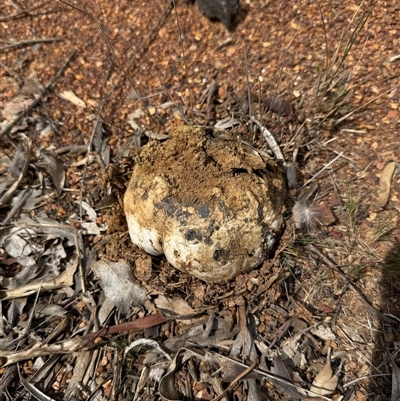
left=133, top=126, right=286, bottom=206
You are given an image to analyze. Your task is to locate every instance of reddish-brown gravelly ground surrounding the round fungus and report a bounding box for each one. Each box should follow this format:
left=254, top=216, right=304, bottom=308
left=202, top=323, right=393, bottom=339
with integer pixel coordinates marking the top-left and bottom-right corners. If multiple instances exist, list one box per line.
left=0, top=0, right=400, bottom=401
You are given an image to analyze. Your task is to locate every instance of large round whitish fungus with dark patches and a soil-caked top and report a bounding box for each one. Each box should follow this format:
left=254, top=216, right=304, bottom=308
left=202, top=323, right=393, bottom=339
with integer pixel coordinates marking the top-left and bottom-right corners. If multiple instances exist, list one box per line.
left=124, top=127, right=286, bottom=282
